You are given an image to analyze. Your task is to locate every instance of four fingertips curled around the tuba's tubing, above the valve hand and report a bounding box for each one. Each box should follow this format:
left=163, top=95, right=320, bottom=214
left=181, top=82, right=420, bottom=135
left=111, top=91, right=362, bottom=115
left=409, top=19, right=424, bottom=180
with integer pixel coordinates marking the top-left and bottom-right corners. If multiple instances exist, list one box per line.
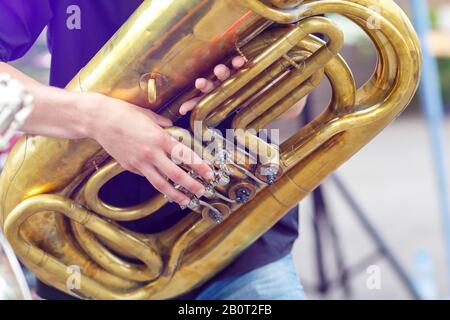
left=180, top=56, right=245, bottom=115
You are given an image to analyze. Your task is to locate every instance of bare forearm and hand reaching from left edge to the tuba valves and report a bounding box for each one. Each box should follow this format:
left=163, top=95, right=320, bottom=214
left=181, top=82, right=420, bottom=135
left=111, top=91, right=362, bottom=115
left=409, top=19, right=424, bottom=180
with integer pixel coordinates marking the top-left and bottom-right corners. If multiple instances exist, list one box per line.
left=0, top=63, right=213, bottom=205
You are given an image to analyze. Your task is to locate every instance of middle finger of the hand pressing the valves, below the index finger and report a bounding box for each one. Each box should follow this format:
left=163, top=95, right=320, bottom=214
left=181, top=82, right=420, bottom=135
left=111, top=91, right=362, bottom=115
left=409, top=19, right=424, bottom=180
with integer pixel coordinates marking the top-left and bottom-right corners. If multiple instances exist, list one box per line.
left=157, top=157, right=205, bottom=198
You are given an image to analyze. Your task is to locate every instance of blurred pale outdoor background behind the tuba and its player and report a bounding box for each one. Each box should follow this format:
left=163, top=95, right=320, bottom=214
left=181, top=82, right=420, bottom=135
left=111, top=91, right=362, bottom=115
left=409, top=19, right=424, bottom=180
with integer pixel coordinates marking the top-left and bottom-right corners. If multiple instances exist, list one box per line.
left=0, top=0, right=450, bottom=299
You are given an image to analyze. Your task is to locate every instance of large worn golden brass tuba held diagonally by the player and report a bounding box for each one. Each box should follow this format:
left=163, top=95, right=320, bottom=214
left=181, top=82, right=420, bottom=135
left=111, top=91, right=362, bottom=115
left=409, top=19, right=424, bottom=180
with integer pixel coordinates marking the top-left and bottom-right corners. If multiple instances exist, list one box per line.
left=0, top=0, right=421, bottom=299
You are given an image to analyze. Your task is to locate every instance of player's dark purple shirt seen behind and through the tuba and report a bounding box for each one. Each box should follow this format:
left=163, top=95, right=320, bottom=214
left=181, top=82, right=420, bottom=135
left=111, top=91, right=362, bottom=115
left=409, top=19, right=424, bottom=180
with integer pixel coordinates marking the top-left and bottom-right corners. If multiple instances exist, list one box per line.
left=0, top=0, right=298, bottom=298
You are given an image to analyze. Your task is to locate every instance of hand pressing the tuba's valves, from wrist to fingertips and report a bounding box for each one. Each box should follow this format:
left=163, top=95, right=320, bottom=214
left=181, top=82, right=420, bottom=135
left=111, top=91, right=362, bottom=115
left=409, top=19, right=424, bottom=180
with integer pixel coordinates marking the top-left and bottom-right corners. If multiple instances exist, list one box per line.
left=89, top=94, right=214, bottom=205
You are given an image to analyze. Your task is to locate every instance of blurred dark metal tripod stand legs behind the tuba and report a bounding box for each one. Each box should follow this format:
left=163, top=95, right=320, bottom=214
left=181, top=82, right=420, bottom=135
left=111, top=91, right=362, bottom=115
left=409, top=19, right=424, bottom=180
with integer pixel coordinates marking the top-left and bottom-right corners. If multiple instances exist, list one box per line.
left=313, top=178, right=420, bottom=299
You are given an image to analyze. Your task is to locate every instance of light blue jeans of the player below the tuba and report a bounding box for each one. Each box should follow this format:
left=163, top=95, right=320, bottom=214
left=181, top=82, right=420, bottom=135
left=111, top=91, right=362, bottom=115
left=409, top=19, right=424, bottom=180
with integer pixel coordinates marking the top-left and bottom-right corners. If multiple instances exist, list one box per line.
left=196, top=254, right=305, bottom=300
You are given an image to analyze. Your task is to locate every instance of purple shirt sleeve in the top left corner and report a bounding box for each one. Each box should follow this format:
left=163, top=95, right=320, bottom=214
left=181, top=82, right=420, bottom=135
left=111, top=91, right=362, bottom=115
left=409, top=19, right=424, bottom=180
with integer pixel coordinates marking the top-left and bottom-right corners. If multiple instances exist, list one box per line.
left=0, top=0, right=52, bottom=62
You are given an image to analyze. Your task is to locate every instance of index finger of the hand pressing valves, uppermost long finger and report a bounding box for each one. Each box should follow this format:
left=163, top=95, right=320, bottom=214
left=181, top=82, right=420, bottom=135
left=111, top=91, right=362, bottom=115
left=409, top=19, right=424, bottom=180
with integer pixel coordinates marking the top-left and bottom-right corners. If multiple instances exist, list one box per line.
left=166, top=139, right=214, bottom=181
